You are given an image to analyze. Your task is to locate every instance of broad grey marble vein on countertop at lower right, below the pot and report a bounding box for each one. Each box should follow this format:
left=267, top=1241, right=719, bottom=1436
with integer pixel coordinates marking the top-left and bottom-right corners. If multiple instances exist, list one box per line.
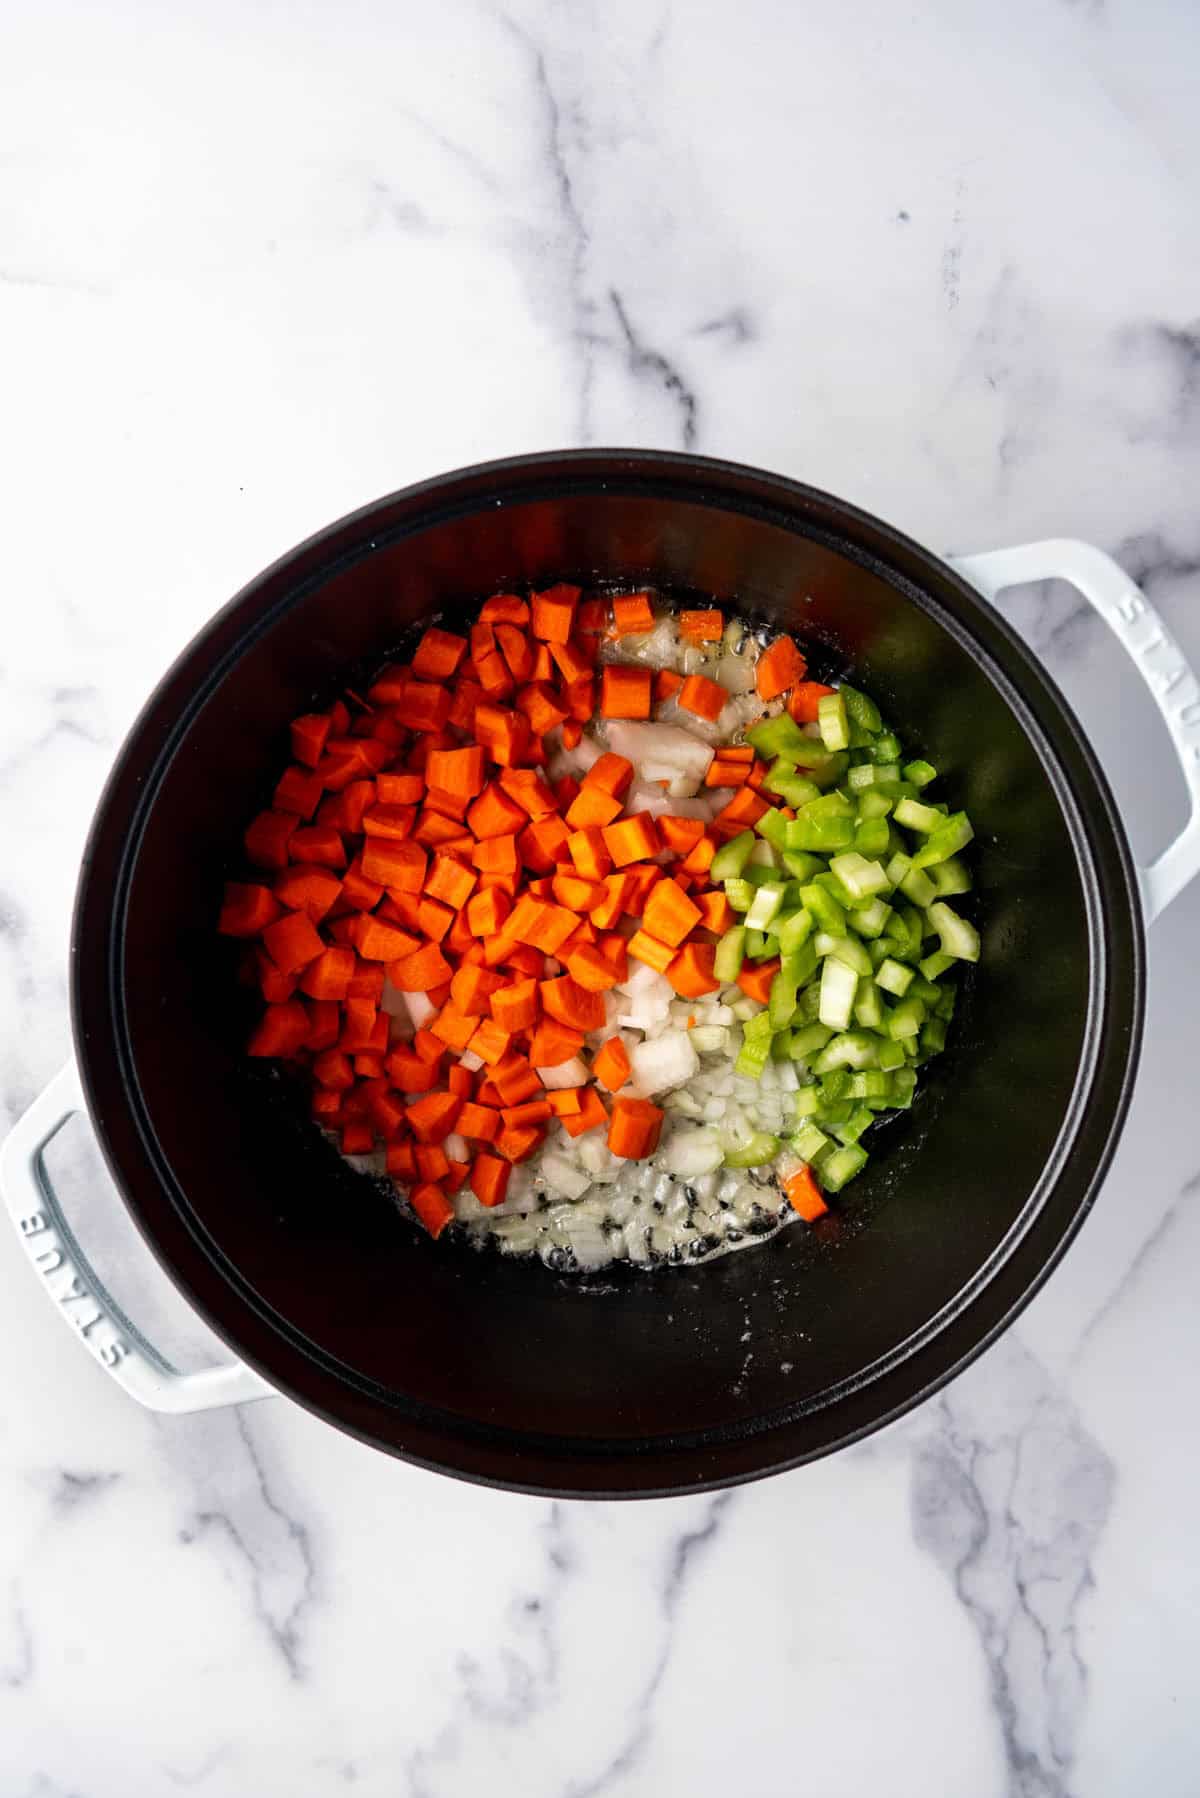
left=912, top=1334, right=1115, bottom=1798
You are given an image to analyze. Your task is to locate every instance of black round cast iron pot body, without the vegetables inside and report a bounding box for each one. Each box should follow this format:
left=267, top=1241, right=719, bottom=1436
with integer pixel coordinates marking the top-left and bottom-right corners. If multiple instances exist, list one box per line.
left=7, top=451, right=1200, bottom=1496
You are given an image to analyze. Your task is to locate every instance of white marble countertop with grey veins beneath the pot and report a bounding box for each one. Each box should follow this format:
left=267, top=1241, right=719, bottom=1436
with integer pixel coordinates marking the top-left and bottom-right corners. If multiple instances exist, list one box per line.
left=0, top=0, right=1200, bottom=1798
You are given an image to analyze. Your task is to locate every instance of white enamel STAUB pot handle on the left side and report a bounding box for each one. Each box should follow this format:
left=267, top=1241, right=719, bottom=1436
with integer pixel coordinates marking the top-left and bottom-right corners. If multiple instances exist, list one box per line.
left=0, top=1061, right=273, bottom=1411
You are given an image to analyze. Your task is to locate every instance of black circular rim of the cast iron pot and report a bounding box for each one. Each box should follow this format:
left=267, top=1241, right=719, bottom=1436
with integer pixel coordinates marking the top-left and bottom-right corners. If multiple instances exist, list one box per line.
left=72, top=450, right=1144, bottom=1498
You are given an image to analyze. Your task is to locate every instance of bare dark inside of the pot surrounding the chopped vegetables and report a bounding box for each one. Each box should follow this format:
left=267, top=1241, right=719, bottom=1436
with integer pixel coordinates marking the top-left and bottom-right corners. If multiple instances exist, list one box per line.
left=79, top=476, right=1128, bottom=1489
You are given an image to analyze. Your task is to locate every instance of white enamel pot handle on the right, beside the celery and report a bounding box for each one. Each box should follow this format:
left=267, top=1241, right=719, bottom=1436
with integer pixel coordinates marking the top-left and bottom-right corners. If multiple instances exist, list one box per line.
left=948, top=538, right=1200, bottom=924
